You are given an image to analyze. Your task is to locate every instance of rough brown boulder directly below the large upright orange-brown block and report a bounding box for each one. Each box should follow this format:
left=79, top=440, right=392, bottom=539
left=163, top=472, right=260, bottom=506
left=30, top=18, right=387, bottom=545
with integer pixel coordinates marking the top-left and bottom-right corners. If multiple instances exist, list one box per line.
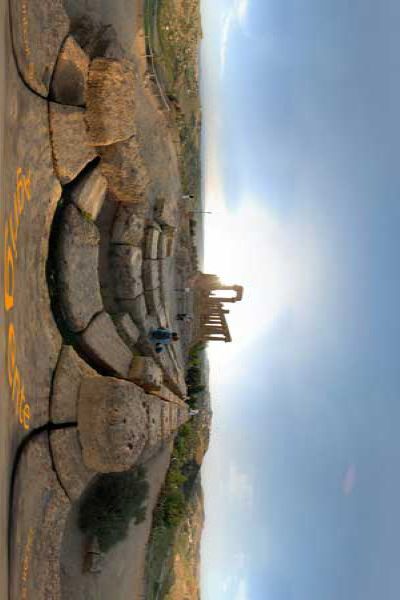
left=100, top=136, right=149, bottom=204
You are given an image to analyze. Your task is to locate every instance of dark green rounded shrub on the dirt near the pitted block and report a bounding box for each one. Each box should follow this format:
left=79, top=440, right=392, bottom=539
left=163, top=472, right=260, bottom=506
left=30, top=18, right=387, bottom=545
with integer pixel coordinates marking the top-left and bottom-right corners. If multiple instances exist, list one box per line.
left=79, top=467, right=149, bottom=552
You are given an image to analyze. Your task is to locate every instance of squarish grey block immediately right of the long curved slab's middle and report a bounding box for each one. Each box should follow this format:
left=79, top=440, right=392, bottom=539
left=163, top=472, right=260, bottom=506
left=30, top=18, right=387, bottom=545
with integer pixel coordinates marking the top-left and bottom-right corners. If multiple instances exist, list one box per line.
left=110, top=245, right=143, bottom=299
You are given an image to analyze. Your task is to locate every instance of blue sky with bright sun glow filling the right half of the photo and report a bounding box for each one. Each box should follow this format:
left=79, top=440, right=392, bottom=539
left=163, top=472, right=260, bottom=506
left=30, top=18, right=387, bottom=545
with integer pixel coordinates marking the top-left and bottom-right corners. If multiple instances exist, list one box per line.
left=202, top=0, right=400, bottom=600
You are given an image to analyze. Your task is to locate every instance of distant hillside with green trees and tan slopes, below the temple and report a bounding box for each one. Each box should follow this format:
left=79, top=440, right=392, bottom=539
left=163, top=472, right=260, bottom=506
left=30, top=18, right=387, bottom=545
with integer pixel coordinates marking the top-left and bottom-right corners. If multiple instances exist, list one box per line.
left=146, top=392, right=212, bottom=600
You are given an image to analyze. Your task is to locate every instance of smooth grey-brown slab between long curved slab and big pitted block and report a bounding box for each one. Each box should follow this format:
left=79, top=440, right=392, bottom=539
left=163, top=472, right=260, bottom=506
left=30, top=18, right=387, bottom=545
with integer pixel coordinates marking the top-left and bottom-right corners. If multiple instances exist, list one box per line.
left=79, top=312, right=132, bottom=377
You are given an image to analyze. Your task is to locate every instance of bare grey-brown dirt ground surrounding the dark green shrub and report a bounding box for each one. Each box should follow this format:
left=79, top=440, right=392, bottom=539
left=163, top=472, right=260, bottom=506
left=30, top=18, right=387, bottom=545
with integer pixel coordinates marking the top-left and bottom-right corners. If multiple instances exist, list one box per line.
left=61, top=447, right=171, bottom=600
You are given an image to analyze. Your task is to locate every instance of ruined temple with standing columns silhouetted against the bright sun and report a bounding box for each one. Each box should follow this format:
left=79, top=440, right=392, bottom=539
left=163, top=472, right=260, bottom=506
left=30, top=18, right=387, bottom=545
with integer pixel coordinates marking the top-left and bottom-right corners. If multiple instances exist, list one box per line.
left=194, top=273, right=243, bottom=342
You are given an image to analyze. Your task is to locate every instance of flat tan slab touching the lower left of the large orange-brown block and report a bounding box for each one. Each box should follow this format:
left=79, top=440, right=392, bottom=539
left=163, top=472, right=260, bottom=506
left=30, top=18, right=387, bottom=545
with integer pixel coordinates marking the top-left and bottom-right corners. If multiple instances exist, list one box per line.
left=49, top=102, right=97, bottom=184
